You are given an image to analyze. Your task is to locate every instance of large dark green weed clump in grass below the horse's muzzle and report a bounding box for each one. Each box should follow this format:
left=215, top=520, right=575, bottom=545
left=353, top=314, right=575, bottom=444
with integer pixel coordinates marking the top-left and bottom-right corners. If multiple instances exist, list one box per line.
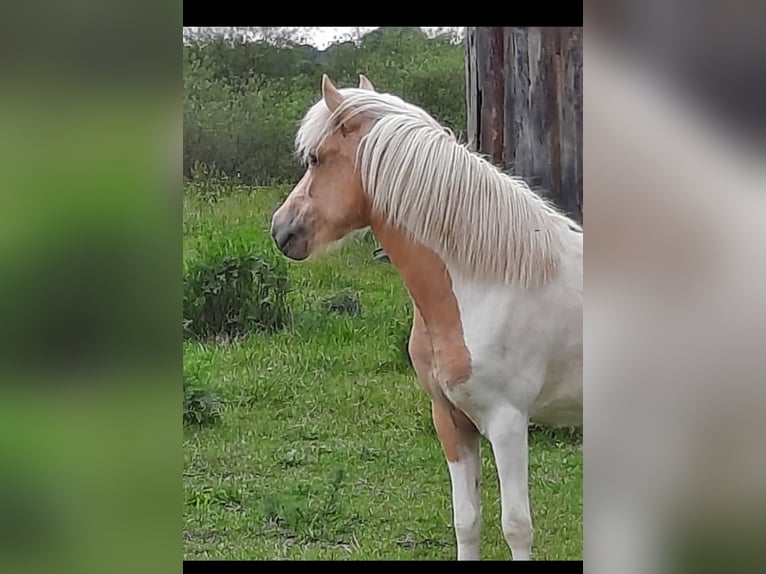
left=183, top=242, right=290, bottom=340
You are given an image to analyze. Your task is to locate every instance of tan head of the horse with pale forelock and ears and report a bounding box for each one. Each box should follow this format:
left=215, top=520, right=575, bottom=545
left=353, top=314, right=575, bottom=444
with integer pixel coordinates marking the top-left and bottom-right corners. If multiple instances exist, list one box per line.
left=271, top=75, right=374, bottom=261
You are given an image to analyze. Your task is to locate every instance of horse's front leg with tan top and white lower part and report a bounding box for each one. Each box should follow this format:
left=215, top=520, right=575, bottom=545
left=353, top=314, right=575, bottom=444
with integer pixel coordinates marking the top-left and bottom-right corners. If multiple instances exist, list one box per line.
left=431, top=401, right=481, bottom=560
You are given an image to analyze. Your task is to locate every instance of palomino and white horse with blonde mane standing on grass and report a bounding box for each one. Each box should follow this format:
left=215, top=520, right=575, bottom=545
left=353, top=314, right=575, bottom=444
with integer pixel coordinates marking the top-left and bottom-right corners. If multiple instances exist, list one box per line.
left=271, top=76, right=583, bottom=560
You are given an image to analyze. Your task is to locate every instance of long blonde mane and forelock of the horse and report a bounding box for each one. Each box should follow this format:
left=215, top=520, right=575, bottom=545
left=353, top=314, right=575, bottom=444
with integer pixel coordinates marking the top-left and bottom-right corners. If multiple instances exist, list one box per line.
left=295, top=88, right=582, bottom=287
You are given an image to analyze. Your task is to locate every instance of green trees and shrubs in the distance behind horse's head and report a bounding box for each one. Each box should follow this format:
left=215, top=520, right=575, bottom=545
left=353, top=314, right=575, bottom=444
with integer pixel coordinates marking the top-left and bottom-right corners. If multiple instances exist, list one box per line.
left=183, top=28, right=466, bottom=185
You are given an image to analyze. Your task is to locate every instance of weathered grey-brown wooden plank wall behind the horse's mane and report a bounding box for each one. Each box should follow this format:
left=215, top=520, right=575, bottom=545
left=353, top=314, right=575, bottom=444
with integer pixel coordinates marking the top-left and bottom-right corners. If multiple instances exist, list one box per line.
left=465, top=27, right=583, bottom=222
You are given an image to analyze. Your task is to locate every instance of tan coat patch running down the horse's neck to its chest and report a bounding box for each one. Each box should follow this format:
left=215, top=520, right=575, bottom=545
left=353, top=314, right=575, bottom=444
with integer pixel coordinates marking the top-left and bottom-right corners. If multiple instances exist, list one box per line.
left=371, top=220, right=472, bottom=378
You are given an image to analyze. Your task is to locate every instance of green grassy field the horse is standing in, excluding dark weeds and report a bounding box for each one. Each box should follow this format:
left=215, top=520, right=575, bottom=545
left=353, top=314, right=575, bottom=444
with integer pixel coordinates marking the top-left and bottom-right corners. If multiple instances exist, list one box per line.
left=183, top=188, right=582, bottom=560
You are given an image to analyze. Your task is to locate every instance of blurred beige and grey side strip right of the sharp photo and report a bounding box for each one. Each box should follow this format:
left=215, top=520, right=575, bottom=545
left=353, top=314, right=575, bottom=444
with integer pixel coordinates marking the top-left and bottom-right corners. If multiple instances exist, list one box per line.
left=584, top=4, right=766, bottom=572
